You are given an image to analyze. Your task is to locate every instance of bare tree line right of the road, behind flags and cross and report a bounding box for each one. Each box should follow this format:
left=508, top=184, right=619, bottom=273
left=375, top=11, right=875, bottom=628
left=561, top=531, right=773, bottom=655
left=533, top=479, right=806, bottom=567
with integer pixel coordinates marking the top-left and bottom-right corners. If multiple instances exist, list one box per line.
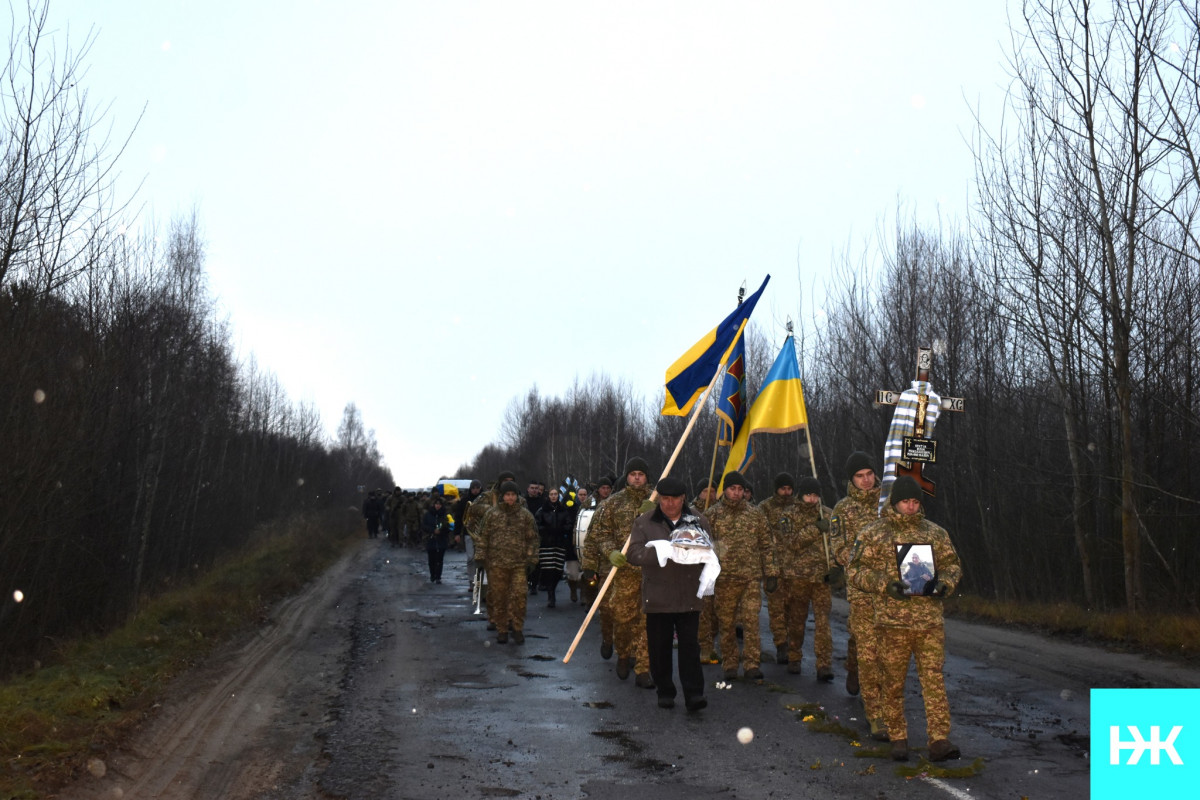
left=460, top=0, right=1200, bottom=613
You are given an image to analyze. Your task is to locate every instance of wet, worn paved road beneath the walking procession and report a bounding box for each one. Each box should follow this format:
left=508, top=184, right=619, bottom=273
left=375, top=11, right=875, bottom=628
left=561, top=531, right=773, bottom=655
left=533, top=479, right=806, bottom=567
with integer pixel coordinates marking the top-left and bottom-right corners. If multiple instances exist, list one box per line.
left=64, top=540, right=1200, bottom=800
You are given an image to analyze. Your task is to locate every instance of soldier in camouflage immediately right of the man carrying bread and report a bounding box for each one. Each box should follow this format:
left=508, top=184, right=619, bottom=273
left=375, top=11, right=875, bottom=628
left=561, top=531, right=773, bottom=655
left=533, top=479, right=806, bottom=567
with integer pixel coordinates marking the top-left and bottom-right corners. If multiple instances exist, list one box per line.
left=707, top=470, right=779, bottom=680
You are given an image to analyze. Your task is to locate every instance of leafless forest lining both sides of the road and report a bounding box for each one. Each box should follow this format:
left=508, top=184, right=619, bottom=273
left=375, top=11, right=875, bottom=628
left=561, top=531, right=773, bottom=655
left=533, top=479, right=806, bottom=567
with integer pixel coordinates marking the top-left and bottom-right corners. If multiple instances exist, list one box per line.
left=0, top=0, right=1200, bottom=667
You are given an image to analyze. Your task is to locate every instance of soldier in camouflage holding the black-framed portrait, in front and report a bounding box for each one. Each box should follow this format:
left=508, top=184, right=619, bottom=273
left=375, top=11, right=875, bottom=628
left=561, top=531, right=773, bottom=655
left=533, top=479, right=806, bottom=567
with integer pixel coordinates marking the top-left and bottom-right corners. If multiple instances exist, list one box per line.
left=847, top=475, right=962, bottom=762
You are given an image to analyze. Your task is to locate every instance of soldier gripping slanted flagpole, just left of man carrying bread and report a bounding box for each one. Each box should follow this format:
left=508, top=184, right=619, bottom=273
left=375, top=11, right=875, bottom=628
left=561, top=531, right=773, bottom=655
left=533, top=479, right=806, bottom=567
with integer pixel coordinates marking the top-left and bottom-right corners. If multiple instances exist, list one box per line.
left=581, top=458, right=654, bottom=688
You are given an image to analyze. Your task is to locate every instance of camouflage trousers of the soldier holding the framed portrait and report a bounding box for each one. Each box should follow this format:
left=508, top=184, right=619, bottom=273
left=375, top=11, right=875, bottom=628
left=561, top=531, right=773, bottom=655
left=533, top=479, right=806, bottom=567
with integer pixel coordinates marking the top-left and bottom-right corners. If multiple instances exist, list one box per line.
left=876, top=626, right=950, bottom=741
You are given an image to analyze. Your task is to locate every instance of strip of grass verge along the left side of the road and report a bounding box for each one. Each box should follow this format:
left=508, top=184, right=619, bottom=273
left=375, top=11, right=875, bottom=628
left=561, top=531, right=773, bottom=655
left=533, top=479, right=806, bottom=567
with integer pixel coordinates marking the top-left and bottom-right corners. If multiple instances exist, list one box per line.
left=0, top=513, right=361, bottom=799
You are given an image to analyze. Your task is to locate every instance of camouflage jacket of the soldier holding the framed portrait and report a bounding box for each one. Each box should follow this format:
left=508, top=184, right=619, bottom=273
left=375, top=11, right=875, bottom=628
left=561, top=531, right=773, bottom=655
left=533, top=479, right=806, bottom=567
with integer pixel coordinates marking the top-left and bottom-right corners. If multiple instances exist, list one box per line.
left=846, top=505, right=962, bottom=630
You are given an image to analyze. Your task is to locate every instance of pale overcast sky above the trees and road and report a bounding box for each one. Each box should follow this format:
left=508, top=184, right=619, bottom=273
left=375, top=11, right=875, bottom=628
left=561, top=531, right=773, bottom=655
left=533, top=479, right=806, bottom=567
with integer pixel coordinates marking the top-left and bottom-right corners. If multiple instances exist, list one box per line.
left=52, top=0, right=1008, bottom=486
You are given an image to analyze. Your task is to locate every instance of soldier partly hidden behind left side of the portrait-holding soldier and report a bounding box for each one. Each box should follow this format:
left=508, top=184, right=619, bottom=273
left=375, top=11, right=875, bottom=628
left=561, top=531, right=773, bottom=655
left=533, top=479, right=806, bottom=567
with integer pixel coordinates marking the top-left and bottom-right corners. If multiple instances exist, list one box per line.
left=829, top=450, right=888, bottom=741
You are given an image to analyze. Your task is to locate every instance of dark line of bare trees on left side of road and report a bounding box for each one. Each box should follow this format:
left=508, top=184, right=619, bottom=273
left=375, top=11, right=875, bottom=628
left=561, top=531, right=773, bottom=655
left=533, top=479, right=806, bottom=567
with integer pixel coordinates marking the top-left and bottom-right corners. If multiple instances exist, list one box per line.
left=0, top=6, right=391, bottom=672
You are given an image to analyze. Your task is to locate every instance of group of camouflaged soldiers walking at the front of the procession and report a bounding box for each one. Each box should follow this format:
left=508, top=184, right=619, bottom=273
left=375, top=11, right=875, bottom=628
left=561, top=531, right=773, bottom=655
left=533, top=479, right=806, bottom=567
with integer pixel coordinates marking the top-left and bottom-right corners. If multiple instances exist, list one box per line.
left=458, top=452, right=962, bottom=762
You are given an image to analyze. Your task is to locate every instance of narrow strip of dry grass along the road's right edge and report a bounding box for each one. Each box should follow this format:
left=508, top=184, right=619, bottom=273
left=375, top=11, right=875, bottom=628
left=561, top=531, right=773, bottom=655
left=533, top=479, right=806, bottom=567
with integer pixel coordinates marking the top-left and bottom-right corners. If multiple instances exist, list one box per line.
left=946, top=596, right=1200, bottom=660
